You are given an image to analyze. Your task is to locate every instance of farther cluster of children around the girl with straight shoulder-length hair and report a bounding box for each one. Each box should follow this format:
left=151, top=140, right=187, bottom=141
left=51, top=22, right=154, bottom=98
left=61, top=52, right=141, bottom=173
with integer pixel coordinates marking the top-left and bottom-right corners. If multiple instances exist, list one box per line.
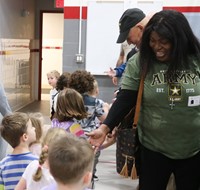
left=47, top=70, right=114, bottom=186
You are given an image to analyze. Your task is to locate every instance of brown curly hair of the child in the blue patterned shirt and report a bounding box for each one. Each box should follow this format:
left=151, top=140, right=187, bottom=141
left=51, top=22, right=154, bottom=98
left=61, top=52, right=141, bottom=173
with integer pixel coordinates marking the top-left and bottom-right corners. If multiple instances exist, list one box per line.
left=69, top=70, right=95, bottom=94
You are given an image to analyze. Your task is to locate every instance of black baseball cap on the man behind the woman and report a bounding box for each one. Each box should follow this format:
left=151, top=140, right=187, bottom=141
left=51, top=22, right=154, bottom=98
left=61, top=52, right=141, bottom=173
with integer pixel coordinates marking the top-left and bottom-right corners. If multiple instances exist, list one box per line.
left=117, top=8, right=146, bottom=43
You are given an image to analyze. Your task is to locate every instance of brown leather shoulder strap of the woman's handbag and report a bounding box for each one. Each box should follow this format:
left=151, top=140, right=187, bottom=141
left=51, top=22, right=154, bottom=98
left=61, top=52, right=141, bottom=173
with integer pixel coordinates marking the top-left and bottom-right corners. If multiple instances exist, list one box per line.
left=133, top=74, right=145, bottom=128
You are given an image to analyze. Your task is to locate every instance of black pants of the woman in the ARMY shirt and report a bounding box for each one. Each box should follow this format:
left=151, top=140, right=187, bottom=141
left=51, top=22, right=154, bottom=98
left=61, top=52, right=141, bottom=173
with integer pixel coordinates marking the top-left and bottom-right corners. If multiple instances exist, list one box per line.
left=139, top=146, right=200, bottom=190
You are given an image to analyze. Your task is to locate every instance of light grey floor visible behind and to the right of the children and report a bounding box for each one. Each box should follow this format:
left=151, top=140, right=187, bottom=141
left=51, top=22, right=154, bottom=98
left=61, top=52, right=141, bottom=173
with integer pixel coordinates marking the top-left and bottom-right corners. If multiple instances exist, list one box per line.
left=19, top=100, right=138, bottom=190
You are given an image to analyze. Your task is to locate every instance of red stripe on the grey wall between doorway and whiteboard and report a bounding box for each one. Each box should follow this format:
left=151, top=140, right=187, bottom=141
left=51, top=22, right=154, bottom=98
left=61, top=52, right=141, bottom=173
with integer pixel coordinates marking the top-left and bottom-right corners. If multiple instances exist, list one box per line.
left=64, top=7, right=87, bottom=19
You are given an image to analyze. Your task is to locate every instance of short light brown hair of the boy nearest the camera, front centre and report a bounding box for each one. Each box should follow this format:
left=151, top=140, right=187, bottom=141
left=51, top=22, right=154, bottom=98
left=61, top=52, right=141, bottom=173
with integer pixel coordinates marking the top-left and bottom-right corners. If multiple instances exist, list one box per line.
left=48, top=133, right=94, bottom=185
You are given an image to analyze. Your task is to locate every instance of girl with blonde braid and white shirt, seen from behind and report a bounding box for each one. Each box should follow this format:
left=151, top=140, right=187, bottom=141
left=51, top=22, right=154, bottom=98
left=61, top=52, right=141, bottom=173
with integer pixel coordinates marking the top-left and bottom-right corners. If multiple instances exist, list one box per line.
left=15, top=128, right=66, bottom=190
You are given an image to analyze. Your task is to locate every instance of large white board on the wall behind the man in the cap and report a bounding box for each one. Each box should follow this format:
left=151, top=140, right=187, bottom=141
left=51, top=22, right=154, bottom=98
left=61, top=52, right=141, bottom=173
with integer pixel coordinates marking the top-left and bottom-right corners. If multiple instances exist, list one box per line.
left=86, top=1, right=163, bottom=75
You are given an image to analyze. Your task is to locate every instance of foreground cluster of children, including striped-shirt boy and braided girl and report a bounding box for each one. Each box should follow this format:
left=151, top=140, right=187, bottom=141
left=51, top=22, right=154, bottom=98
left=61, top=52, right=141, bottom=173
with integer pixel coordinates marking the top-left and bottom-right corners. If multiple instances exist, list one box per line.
left=0, top=112, right=94, bottom=190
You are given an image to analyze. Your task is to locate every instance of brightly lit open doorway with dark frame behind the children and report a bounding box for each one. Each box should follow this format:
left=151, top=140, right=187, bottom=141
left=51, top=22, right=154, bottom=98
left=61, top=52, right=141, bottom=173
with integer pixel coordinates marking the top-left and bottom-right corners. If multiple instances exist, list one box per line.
left=38, top=11, right=64, bottom=100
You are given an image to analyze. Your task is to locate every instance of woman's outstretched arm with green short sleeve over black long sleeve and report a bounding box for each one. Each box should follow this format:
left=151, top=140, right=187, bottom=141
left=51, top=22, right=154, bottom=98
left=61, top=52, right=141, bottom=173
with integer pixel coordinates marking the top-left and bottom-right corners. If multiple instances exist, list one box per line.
left=87, top=54, right=140, bottom=147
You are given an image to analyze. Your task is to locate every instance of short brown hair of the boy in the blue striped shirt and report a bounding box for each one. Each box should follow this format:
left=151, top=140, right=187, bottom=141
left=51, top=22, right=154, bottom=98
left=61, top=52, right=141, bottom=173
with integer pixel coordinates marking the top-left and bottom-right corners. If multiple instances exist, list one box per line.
left=0, top=112, right=30, bottom=148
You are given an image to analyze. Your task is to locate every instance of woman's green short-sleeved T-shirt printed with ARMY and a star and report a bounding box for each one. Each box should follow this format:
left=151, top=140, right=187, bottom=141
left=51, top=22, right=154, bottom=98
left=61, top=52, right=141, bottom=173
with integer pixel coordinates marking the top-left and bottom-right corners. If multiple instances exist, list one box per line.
left=122, top=54, right=200, bottom=159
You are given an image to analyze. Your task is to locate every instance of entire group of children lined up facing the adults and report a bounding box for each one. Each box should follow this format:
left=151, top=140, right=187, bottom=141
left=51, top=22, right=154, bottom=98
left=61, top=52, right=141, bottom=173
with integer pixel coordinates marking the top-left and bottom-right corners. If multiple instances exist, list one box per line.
left=0, top=71, right=114, bottom=190
